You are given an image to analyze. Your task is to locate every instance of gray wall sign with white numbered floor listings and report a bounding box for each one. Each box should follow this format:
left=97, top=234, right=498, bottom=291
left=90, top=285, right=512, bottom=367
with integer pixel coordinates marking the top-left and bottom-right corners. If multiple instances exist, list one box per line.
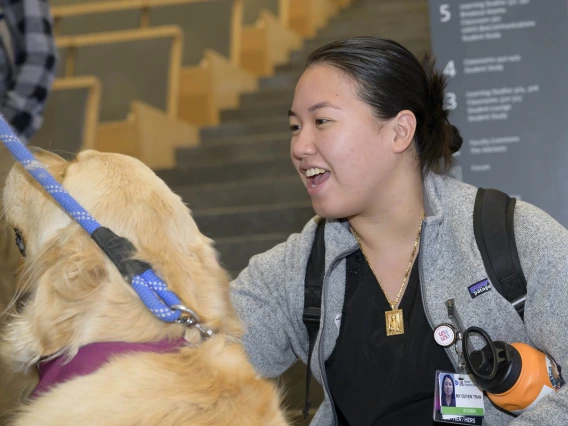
left=429, top=0, right=568, bottom=226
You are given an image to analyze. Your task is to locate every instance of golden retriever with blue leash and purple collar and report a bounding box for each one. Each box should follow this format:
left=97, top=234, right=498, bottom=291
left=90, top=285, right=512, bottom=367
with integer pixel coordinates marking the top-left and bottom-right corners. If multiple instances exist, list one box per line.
left=2, top=151, right=287, bottom=426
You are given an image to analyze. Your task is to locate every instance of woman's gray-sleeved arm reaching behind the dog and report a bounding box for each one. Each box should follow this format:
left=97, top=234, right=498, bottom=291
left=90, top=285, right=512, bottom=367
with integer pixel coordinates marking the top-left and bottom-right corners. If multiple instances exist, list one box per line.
left=231, top=237, right=302, bottom=377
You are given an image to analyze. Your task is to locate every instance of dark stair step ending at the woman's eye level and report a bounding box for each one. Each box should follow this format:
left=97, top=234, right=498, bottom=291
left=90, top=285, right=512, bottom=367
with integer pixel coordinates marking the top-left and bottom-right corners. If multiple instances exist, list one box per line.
left=200, top=116, right=290, bottom=141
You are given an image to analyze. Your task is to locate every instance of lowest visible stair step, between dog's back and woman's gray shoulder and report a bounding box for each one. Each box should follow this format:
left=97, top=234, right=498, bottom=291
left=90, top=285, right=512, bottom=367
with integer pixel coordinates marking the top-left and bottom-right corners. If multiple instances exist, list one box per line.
left=215, top=233, right=290, bottom=278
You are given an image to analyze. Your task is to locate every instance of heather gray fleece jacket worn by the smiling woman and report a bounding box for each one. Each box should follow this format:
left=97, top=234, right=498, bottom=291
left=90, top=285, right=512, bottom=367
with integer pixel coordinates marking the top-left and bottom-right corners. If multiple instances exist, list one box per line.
left=232, top=173, right=568, bottom=426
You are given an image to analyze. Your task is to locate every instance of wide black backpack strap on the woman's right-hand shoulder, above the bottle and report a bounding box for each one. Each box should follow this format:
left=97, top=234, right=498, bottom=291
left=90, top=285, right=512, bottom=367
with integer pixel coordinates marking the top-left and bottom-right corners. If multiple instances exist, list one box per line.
left=473, top=188, right=527, bottom=319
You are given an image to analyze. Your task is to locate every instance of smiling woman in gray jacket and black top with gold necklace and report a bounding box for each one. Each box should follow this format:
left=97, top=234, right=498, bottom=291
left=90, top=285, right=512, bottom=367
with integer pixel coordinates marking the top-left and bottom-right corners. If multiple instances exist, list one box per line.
left=232, top=37, right=568, bottom=426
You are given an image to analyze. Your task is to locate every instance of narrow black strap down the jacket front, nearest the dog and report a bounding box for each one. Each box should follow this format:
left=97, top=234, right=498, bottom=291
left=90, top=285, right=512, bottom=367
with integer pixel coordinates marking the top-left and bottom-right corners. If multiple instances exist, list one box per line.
left=302, top=218, right=325, bottom=419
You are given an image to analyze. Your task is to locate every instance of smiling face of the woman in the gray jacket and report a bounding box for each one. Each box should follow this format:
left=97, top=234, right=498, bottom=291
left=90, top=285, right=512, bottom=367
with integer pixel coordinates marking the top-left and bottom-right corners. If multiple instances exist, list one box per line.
left=289, top=65, right=395, bottom=218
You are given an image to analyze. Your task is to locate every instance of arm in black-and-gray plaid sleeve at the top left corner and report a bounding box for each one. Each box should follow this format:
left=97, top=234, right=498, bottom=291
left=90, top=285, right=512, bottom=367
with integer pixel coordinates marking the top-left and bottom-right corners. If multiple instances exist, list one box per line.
left=0, top=0, right=57, bottom=143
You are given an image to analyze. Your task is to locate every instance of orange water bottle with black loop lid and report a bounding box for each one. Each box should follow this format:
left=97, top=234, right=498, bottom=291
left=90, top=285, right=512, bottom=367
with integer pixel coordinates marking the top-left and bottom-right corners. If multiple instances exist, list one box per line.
left=462, top=327, right=564, bottom=414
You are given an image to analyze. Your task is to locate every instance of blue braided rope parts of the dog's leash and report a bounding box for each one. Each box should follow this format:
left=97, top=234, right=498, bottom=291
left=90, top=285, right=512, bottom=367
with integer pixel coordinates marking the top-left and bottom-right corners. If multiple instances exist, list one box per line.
left=0, top=117, right=181, bottom=322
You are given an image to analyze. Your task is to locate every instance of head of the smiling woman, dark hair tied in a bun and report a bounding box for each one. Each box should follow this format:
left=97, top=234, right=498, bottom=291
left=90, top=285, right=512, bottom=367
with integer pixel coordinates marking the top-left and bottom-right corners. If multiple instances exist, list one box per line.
left=288, top=38, right=461, bottom=220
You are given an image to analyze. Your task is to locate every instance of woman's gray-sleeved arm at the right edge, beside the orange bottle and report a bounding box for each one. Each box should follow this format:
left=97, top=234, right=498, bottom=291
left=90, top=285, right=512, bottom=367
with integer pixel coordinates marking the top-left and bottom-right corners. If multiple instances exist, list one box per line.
left=510, top=203, right=568, bottom=426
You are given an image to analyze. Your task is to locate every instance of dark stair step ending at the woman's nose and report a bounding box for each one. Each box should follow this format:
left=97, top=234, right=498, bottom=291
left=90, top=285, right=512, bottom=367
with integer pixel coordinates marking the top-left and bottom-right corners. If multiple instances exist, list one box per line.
left=176, top=132, right=290, bottom=164
